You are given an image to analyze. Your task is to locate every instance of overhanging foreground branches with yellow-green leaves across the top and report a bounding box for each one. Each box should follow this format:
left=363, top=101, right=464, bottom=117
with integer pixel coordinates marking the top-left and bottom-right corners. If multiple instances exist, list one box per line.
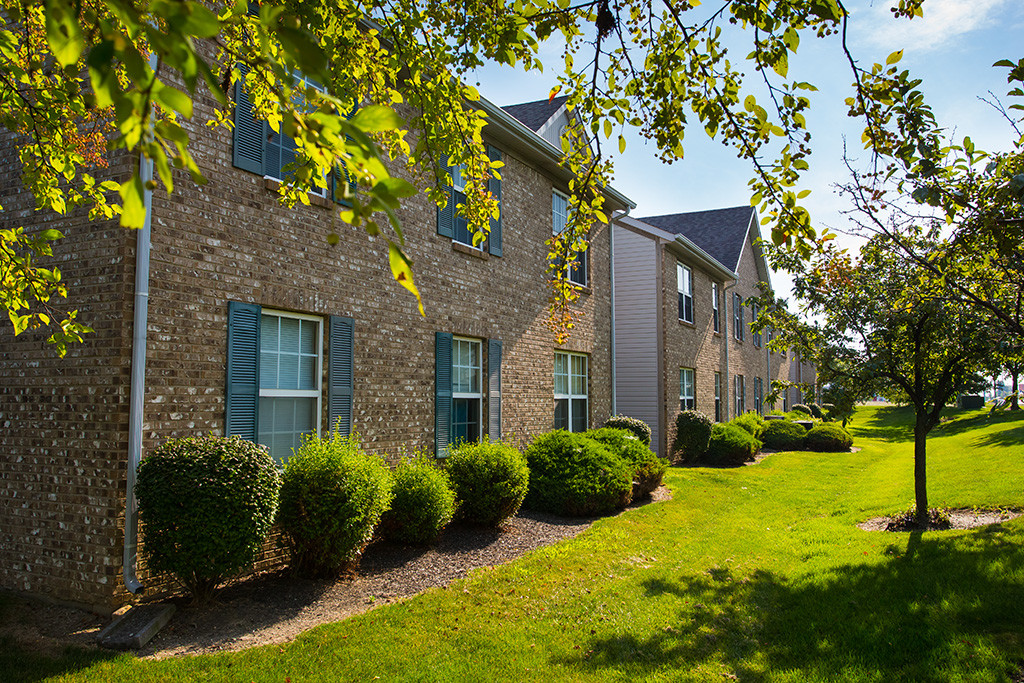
left=0, top=0, right=1007, bottom=350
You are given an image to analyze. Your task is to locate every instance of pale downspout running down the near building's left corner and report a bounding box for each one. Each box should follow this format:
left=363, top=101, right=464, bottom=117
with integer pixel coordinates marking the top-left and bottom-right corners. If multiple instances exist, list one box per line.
left=122, top=54, right=157, bottom=594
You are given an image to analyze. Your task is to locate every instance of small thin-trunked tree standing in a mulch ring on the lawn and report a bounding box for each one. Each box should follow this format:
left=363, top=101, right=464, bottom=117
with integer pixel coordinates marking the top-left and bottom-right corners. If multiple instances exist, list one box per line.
left=765, top=234, right=996, bottom=525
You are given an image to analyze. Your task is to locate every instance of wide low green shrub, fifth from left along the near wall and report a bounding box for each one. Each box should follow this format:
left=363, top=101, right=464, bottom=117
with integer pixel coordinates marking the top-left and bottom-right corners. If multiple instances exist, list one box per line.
left=525, top=430, right=633, bottom=516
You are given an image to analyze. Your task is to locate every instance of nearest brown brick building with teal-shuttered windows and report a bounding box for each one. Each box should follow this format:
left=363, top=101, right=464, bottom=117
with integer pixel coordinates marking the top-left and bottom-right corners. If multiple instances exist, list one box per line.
left=0, top=82, right=632, bottom=611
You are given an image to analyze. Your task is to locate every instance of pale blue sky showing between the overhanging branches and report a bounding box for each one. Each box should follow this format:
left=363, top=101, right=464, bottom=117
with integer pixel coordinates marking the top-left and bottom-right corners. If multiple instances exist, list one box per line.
left=468, top=0, right=1024, bottom=295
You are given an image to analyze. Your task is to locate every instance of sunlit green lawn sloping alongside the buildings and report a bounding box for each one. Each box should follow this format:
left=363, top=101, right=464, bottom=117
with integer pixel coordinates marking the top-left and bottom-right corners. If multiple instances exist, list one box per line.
left=9, top=408, right=1024, bottom=682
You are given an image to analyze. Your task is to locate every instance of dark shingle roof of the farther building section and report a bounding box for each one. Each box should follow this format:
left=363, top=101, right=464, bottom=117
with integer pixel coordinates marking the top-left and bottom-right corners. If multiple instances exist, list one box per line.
left=637, top=206, right=754, bottom=270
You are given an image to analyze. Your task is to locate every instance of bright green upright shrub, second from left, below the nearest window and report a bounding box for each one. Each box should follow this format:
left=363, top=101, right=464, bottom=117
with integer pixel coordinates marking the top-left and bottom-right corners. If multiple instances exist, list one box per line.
left=278, top=432, right=393, bottom=577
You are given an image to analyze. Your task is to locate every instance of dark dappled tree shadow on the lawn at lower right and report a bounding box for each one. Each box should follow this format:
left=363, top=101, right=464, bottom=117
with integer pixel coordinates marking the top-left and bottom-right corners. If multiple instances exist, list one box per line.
left=563, top=528, right=1024, bottom=681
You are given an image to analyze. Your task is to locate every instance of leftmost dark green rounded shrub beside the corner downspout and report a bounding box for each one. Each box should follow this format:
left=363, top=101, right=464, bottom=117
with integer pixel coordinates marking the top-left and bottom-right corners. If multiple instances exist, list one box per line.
left=135, top=436, right=281, bottom=602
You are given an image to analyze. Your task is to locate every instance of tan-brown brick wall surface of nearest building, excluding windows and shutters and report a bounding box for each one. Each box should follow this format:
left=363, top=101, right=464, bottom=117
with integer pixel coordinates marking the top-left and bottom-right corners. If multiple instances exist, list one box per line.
left=0, top=89, right=611, bottom=610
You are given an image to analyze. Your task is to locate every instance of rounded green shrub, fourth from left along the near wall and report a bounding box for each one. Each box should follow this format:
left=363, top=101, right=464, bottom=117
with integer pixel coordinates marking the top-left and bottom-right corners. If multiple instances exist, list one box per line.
left=446, top=440, right=529, bottom=526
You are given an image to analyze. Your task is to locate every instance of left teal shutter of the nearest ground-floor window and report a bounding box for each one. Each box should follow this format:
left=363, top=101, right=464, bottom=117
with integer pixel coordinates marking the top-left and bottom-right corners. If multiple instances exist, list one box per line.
left=224, top=301, right=260, bottom=441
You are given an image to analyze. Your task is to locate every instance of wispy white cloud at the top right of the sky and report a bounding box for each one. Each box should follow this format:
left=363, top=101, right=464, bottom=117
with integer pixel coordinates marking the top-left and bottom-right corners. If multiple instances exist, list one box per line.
left=852, top=0, right=1017, bottom=50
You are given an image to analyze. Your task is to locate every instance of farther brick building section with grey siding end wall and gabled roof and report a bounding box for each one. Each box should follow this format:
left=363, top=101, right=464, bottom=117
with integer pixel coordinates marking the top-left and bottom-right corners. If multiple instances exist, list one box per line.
left=612, top=207, right=814, bottom=456
